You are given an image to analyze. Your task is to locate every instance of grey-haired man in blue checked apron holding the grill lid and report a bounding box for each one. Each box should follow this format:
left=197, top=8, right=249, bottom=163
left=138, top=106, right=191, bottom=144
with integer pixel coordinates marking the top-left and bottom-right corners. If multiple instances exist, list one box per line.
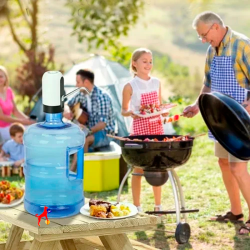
left=183, top=12, right=250, bottom=234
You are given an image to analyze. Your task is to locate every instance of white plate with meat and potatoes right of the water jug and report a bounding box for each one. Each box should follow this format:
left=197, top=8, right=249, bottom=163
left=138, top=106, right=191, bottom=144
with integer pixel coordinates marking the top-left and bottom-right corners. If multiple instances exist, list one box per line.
left=80, top=200, right=138, bottom=220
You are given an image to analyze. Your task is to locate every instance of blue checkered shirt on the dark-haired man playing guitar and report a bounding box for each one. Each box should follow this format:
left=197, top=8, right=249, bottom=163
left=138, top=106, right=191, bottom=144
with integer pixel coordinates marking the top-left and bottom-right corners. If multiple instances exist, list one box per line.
left=68, top=86, right=115, bottom=134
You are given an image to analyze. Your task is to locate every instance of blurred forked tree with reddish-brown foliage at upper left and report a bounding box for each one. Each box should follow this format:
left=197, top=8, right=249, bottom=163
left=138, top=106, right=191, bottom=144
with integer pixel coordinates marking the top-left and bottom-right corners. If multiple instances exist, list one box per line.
left=0, top=0, right=62, bottom=105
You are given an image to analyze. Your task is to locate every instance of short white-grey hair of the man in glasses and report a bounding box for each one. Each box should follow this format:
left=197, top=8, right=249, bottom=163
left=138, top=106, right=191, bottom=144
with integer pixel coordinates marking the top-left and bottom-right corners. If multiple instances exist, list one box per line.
left=192, top=11, right=224, bottom=29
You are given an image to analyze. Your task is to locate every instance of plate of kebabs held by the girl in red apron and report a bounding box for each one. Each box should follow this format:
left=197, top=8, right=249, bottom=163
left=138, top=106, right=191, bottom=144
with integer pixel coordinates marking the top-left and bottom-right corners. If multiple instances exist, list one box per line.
left=134, top=103, right=177, bottom=118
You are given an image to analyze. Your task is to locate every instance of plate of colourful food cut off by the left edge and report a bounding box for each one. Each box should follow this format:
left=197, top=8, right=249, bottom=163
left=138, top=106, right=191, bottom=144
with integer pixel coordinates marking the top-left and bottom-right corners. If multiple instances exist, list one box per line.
left=0, top=181, right=24, bottom=208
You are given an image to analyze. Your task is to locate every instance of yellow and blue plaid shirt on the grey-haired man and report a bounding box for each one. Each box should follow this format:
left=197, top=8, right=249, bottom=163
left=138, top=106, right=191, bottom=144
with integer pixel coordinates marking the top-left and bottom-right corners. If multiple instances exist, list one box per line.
left=204, top=27, right=250, bottom=89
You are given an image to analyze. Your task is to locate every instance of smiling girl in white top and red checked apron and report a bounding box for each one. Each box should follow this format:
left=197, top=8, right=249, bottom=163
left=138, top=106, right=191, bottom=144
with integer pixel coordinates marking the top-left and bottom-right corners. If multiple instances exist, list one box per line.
left=122, top=48, right=168, bottom=211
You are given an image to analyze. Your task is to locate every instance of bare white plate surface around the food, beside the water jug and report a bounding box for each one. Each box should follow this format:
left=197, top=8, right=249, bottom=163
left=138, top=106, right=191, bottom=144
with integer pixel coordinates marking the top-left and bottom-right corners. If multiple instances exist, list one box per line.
left=80, top=201, right=138, bottom=220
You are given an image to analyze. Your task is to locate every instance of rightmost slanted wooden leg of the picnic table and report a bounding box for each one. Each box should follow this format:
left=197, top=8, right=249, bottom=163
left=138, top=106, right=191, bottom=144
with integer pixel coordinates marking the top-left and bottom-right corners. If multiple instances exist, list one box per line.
left=99, top=234, right=134, bottom=250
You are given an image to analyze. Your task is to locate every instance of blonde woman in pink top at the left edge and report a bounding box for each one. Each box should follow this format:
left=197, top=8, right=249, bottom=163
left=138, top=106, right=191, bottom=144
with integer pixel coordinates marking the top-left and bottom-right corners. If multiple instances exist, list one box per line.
left=0, top=65, right=34, bottom=143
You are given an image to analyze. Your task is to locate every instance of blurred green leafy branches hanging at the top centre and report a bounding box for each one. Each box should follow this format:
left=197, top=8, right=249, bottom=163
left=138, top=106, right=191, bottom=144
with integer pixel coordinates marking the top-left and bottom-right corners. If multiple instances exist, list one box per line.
left=67, top=0, right=144, bottom=50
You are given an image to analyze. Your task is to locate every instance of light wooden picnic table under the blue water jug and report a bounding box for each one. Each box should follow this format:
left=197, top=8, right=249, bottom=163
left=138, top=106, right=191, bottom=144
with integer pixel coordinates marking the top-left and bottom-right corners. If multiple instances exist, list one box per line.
left=0, top=203, right=161, bottom=250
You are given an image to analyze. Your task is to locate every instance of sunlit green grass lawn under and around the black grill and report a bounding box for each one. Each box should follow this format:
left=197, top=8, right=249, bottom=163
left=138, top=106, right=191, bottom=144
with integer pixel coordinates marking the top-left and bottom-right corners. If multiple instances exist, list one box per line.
left=0, top=105, right=250, bottom=250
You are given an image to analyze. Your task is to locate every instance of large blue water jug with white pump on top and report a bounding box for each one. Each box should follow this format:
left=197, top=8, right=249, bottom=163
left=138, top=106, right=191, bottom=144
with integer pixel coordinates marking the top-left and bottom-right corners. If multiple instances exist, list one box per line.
left=24, top=71, right=85, bottom=218
